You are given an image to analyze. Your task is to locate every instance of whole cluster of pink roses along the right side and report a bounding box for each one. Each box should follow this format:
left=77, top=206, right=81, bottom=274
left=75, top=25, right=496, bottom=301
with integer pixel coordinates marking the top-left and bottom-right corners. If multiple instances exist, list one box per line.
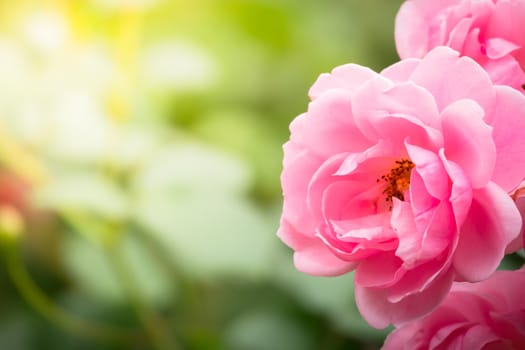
left=278, top=0, right=525, bottom=349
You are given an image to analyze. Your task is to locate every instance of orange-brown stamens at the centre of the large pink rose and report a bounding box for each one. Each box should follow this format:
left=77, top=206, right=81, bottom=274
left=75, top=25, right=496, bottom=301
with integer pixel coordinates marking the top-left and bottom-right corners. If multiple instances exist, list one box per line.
left=377, top=159, right=414, bottom=205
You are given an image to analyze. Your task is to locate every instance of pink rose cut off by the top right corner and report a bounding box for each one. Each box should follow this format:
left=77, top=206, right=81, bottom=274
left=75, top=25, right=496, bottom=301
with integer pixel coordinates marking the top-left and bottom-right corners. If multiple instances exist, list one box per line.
left=395, top=0, right=525, bottom=93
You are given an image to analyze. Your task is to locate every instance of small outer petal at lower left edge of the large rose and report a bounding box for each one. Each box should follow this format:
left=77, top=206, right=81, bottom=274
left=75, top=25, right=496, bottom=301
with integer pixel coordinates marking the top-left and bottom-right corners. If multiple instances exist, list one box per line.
left=294, top=240, right=357, bottom=276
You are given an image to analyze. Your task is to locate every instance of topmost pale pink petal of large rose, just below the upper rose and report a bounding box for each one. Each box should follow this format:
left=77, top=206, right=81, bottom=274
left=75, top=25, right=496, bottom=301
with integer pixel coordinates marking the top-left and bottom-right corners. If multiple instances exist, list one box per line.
left=411, top=46, right=495, bottom=110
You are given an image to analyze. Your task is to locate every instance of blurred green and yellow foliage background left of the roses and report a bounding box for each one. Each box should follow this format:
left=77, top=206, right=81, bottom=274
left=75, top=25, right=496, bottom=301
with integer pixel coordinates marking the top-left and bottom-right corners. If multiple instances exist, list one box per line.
left=0, top=0, right=401, bottom=350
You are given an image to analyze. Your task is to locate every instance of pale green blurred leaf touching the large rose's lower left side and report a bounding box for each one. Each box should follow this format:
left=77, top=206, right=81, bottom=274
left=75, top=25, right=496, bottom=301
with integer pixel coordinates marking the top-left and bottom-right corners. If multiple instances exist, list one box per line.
left=137, top=194, right=277, bottom=278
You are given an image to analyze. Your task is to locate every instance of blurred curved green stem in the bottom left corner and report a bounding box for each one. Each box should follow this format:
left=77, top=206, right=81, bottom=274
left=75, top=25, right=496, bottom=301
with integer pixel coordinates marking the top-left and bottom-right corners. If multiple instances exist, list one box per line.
left=4, top=239, right=139, bottom=343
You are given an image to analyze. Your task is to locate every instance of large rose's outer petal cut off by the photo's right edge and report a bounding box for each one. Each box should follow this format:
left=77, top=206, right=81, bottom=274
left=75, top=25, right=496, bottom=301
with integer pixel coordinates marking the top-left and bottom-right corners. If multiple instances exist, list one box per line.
left=485, top=86, right=525, bottom=192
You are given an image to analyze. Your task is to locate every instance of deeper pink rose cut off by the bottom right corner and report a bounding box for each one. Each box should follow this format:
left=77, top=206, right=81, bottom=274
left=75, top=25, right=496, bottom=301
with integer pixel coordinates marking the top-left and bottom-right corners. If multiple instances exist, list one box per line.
left=383, top=269, right=525, bottom=350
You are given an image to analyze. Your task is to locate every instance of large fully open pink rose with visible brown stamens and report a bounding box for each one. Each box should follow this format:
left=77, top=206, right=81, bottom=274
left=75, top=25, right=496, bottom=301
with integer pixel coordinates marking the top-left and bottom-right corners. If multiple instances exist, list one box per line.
left=278, top=47, right=525, bottom=328
